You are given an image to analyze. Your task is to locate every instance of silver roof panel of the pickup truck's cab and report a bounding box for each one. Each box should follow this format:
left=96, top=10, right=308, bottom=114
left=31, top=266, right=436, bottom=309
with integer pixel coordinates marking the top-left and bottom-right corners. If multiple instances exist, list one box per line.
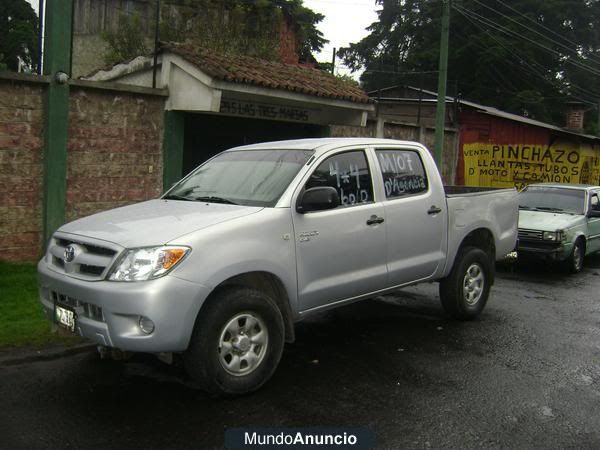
left=228, top=138, right=421, bottom=156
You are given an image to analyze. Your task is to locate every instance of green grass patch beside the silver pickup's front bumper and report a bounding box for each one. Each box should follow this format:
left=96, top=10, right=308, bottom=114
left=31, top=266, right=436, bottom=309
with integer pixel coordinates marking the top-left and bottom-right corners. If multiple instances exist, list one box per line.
left=0, top=262, right=81, bottom=349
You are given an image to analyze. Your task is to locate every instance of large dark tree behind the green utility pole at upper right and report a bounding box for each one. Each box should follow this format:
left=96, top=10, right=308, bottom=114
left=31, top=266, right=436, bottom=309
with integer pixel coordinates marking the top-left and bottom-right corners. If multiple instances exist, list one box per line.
left=339, top=0, right=600, bottom=130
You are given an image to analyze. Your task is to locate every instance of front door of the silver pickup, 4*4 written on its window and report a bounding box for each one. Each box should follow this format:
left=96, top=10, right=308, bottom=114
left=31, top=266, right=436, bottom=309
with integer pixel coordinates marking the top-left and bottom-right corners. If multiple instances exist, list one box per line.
left=292, top=150, right=387, bottom=311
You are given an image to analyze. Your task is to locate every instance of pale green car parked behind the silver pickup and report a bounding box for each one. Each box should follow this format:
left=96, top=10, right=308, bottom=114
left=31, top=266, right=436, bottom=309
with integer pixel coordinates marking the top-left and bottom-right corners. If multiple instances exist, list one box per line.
left=517, top=183, right=600, bottom=273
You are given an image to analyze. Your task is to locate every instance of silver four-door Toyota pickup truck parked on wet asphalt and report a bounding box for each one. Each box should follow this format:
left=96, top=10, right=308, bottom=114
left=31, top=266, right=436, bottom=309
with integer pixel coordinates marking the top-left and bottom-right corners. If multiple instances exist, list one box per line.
left=38, top=138, right=518, bottom=395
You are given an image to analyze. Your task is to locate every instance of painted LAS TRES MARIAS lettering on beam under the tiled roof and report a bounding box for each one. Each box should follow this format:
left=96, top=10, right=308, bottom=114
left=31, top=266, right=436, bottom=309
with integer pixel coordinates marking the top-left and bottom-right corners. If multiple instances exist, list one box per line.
left=220, top=98, right=315, bottom=123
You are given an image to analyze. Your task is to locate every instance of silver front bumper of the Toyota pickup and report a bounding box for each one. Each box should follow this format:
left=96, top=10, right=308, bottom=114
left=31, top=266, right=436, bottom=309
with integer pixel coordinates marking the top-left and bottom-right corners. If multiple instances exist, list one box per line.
left=38, top=259, right=210, bottom=353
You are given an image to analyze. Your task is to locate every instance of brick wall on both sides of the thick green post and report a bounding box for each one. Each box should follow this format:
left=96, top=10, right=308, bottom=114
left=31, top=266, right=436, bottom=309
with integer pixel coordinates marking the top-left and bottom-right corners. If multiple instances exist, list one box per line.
left=0, top=77, right=164, bottom=261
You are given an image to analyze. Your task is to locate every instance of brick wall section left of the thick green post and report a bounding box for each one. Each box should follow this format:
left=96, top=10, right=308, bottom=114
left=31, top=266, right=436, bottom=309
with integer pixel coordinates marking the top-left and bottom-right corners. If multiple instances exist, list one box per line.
left=0, top=80, right=44, bottom=260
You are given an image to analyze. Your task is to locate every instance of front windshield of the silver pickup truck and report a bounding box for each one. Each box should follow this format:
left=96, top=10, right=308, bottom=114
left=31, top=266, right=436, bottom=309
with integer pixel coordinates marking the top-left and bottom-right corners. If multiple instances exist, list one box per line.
left=163, top=149, right=313, bottom=207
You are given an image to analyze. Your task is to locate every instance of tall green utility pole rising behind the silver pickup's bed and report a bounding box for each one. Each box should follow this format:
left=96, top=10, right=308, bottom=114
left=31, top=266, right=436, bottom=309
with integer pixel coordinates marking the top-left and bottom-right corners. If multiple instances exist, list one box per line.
left=435, top=0, right=450, bottom=172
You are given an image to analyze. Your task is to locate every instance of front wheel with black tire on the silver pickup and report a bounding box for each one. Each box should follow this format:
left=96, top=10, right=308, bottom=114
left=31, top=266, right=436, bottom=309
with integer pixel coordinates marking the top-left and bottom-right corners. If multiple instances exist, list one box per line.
left=183, top=287, right=285, bottom=396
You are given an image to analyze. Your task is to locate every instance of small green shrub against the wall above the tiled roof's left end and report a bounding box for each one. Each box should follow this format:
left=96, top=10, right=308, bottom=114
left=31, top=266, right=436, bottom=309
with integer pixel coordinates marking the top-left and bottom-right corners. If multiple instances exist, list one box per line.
left=102, top=12, right=149, bottom=65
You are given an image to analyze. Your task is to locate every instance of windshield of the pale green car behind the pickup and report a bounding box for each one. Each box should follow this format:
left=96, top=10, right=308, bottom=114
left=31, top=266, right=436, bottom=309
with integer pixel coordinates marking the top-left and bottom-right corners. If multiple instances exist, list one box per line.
left=519, top=186, right=585, bottom=214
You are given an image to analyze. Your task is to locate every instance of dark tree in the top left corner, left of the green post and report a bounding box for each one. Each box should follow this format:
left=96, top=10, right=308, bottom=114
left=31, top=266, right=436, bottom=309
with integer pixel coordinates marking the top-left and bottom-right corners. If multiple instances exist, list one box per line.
left=0, top=0, right=38, bottom=71
